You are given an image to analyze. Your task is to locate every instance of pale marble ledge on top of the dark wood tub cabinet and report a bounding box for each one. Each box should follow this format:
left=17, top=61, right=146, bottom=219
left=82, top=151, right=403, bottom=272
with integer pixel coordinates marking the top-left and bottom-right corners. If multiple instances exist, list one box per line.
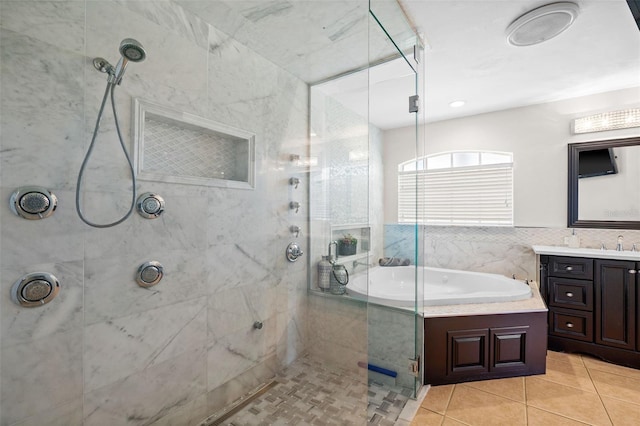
left=422, top=281, right=547, bottom=318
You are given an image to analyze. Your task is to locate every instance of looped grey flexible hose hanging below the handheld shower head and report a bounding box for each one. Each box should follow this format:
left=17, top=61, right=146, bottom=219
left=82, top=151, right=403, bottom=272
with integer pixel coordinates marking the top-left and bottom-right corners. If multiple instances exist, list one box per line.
left=76, top=82, right=136, bottom=228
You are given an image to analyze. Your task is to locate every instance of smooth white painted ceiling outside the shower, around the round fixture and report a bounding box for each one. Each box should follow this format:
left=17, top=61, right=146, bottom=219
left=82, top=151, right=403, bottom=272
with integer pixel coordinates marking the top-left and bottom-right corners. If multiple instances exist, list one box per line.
left=400, top=0, right=640, bottom=128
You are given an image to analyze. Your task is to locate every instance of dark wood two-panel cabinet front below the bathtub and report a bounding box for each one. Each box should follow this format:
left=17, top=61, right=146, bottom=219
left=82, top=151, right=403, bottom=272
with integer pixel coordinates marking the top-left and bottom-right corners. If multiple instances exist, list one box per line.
left=424, top=311, right=547, bottom=385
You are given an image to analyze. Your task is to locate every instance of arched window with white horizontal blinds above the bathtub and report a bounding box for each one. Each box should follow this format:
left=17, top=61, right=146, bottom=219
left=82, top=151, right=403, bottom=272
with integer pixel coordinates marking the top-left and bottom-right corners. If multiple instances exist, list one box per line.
left=398, top=151, right=513, bottom=226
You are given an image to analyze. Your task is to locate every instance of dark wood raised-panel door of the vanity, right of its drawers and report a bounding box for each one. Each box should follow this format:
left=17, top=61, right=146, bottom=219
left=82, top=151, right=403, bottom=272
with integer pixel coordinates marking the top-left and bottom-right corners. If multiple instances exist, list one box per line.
left=595, top=259, right=637, bottom=350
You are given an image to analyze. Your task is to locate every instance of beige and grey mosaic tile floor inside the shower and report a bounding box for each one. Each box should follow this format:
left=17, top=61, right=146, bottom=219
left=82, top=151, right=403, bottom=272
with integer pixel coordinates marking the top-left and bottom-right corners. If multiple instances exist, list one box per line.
left=208, top=357, right=410, bottom=426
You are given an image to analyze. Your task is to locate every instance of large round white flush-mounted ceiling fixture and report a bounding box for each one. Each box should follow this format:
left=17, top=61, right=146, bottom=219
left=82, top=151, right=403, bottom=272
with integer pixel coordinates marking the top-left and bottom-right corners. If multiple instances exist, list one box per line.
left=507, top=2, right=580, bottom=46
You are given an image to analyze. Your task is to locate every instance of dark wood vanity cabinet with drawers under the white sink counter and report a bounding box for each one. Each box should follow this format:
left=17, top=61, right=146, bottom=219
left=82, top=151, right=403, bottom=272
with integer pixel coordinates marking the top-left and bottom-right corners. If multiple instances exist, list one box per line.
left=540, top=255, right=640, bottom=368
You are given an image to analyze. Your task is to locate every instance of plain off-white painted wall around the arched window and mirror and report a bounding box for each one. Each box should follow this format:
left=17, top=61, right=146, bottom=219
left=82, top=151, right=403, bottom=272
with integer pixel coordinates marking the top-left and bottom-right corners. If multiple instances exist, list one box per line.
left=383, top=87, right=640, bottom=227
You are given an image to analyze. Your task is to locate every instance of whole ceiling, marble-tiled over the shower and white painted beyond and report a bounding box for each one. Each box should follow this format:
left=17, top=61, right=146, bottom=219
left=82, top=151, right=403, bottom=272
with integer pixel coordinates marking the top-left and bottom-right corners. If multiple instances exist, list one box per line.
left=180, top=0, right=640, bottom=129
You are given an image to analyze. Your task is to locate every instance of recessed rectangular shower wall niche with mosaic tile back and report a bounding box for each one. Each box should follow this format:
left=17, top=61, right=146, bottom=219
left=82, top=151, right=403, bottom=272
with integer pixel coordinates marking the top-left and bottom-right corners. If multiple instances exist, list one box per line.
left=134, top=99, right=255, bottom=189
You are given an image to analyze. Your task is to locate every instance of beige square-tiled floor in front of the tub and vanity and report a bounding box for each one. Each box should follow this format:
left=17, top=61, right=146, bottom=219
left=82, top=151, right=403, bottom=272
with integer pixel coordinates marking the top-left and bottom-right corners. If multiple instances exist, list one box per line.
left=411, top=351, right=640, bottom=426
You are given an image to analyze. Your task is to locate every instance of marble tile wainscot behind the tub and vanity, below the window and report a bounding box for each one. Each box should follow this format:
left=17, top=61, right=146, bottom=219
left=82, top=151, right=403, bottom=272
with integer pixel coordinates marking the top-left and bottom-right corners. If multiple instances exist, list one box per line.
left=384, top=224, right=640, bottom=279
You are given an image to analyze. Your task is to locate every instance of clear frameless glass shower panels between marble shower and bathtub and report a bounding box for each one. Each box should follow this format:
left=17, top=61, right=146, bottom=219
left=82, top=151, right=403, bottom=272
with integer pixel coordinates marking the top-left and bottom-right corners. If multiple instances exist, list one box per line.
left=309, top=1, right=424, bottom=397
